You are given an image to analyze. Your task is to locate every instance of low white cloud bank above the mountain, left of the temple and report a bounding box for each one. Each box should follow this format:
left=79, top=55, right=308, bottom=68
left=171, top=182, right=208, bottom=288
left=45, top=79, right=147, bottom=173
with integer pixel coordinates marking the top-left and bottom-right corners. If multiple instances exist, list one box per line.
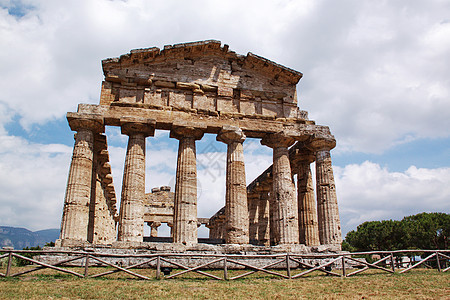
left=0, top=135, right=72, bottom=230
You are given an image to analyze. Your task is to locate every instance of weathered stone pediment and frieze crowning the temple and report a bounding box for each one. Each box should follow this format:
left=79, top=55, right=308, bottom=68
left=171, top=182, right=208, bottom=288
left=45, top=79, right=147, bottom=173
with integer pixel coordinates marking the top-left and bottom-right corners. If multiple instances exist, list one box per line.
left=100, top=40, right=305, bottom=119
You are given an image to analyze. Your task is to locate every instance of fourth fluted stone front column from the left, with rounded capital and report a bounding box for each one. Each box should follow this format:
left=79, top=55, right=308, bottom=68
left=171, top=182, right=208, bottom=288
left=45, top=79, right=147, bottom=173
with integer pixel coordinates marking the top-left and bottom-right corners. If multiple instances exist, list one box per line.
left=217, top=126, right=249, bottom=244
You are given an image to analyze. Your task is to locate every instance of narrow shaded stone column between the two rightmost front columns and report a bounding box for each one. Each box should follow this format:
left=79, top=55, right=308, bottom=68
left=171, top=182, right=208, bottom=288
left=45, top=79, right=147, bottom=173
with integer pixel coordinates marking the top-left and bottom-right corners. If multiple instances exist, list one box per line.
left=296, top=152, right=320, bottom=246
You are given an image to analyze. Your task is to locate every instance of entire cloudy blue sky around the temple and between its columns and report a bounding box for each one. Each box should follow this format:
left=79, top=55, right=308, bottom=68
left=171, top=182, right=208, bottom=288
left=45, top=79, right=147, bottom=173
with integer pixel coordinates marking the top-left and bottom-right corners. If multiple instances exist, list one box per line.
left=0, top=0, right=450, bottom=239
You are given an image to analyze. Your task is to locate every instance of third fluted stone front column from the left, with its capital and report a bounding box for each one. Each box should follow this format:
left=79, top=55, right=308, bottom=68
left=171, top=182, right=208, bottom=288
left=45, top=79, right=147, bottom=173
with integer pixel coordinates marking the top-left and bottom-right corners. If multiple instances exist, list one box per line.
left=170, top=127, right=203, bottom=244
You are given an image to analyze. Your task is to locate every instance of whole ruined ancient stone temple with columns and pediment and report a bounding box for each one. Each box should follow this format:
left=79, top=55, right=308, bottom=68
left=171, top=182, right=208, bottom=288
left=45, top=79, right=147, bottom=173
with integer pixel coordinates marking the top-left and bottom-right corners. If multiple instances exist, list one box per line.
left=57, top=40, right=341, bottom=249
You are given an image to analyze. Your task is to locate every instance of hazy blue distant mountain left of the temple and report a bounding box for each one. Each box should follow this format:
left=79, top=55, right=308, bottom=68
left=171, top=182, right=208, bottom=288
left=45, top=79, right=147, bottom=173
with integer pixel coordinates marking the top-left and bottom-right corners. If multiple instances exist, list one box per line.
left=0, top=226, right=59, bottom=250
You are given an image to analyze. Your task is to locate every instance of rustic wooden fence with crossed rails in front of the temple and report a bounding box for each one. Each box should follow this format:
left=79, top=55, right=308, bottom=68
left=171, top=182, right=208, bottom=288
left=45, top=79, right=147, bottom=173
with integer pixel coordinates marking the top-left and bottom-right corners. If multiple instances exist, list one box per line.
left=0, top=249, right=450, bottom=280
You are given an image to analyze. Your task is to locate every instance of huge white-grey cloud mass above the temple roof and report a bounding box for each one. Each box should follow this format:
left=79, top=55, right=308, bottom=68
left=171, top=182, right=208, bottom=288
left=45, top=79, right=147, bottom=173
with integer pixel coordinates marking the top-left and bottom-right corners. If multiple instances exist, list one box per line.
left=0, top=0, right=450, bottom=153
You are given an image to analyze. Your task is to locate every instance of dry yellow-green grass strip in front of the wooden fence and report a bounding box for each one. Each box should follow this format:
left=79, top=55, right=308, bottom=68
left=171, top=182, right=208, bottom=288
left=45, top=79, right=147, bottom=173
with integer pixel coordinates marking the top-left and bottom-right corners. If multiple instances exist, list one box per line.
left=0, top=269, right=450, bottom=299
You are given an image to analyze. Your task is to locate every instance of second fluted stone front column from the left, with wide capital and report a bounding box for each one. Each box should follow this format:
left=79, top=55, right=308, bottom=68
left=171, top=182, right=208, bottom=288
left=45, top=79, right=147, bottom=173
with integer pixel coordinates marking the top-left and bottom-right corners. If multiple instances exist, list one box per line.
left=117, top=118, right=155, bottom=242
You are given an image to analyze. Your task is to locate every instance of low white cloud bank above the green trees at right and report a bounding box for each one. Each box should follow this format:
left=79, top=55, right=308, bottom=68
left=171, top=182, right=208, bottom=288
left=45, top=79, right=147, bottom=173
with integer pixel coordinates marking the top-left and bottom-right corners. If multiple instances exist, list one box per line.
left=334, top=161, right=450, bottom=233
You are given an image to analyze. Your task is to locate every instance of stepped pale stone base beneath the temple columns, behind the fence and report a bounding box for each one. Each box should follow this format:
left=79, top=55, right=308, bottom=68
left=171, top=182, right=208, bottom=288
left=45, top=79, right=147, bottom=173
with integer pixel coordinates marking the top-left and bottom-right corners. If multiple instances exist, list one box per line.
left=39, top=240, right=342, bottom=269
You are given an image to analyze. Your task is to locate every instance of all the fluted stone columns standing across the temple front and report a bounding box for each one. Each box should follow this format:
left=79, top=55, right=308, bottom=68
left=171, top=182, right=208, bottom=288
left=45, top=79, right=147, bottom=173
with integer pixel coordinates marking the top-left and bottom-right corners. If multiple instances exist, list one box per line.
left=61, top=118, right=340, bottom=244
